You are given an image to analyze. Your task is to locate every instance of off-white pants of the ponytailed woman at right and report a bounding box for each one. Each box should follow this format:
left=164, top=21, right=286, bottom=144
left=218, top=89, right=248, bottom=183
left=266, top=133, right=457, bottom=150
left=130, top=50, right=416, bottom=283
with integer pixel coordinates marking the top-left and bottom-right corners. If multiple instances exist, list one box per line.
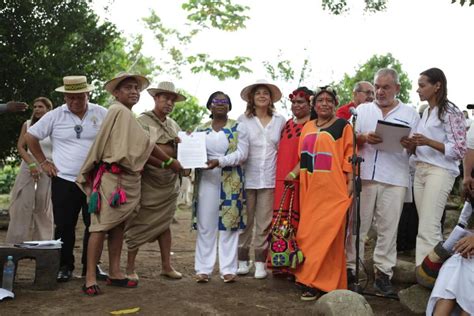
left=413, top=162, right=455, bottom=266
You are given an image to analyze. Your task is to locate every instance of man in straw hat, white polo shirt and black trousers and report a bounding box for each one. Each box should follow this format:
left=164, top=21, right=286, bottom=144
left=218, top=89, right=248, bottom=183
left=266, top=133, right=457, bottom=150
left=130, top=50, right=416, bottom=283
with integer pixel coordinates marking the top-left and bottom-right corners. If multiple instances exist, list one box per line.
left=25, top=76, right=107, bottom=282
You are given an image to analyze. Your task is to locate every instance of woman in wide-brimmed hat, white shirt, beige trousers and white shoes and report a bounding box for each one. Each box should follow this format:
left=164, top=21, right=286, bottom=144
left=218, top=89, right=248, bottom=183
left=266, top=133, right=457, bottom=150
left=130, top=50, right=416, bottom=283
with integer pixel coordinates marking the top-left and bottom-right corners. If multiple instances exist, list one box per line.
left=237, top=81, right=286, bottom=279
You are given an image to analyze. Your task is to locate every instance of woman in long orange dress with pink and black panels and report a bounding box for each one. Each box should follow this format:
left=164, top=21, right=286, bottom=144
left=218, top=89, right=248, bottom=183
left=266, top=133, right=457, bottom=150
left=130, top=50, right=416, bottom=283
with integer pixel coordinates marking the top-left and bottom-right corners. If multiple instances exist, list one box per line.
left=293, top=86, right=353, bottom=300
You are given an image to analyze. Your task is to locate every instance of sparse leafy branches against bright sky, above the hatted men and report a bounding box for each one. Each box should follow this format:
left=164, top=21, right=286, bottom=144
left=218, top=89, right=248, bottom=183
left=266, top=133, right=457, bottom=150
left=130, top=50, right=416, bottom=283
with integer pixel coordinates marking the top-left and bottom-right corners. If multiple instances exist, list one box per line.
left=144, top=0, right=251, bottom=80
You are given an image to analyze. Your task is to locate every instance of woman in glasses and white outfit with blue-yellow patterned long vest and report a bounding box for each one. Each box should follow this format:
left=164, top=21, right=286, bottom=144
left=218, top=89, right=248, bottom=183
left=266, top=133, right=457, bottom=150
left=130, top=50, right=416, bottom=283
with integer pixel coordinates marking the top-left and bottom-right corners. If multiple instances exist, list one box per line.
left=193, top=91, right=248, bottom=283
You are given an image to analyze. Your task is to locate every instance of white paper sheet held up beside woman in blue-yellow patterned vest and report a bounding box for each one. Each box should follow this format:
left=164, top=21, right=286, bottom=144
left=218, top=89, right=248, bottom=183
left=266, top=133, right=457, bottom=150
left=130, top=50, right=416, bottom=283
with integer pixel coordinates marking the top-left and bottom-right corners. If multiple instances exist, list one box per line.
left=178, top=132, right=207, bottom=169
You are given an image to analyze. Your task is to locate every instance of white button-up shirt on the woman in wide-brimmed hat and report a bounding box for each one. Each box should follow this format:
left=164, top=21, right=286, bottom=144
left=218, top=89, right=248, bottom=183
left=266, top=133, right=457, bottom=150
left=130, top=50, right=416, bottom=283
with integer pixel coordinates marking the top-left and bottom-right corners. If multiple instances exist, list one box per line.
left=238, top=113, right=286, bottom=189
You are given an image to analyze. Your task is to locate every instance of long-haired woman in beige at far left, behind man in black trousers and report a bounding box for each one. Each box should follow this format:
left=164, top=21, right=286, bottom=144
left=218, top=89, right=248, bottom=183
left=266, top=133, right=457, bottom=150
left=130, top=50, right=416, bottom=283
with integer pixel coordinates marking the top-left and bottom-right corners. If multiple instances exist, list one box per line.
left=5, top=97, right=53, bottom=244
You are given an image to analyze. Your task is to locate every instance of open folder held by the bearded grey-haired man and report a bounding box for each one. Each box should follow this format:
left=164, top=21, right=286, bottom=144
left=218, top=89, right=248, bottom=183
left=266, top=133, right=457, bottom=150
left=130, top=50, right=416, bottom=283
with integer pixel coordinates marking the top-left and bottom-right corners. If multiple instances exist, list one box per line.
left=373, top=120, right=411, bottom=153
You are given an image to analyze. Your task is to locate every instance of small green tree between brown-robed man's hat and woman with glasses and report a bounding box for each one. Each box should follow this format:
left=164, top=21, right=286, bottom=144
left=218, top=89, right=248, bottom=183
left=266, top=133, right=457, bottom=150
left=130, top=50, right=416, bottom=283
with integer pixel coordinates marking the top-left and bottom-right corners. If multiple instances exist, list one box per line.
left=170, top=90, right=208, bottom=131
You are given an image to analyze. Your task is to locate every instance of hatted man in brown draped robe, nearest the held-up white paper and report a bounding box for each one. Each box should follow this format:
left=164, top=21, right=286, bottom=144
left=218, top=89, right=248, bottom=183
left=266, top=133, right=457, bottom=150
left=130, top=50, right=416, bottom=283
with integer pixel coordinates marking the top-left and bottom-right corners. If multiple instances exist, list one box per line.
left=125, top=81, right=186, bottom=279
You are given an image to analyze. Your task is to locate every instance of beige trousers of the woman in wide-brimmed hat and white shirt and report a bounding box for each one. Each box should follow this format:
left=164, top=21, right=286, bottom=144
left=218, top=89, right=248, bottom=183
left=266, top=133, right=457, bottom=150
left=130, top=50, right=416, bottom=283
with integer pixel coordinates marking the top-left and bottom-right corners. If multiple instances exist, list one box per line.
left=238, top=189, right=273, bottom=262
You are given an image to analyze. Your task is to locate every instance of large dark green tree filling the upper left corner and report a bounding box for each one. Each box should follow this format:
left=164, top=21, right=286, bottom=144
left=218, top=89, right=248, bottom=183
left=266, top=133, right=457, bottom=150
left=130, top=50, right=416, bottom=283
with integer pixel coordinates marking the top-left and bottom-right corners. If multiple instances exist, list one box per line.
left=0, top=0, right=152, bottom=160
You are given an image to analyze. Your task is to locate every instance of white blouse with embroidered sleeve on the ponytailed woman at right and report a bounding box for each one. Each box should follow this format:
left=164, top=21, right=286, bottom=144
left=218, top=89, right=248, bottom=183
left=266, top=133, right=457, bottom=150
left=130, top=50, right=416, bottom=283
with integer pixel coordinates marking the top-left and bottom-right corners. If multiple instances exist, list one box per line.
left=414, top=106, right=466, bottom=177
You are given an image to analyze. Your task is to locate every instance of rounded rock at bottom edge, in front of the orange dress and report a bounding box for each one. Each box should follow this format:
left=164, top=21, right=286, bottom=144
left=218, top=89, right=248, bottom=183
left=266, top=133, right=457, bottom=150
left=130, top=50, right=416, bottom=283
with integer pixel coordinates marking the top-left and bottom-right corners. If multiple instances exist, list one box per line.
left=311, top=290, right=374, bottom=316
